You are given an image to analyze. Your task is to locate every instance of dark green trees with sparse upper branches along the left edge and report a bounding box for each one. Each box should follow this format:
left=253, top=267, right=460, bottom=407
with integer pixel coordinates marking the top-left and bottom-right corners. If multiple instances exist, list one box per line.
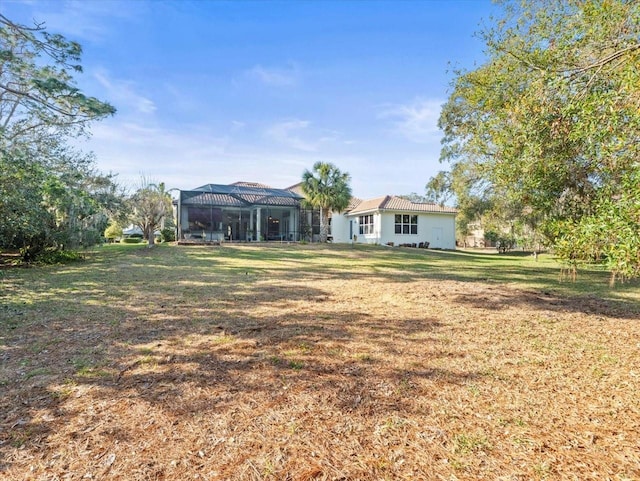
left=0, top=14, right=120, bottom=259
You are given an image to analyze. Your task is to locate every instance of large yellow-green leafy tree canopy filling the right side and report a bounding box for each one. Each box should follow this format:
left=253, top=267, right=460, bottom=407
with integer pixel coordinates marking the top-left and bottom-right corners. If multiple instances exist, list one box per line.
left=440, top=0, right=640, bottom=278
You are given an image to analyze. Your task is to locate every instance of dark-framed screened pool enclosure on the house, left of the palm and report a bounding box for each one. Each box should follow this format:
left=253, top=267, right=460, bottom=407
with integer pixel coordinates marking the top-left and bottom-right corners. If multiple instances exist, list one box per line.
left=174, top=183, right=307, bottom=242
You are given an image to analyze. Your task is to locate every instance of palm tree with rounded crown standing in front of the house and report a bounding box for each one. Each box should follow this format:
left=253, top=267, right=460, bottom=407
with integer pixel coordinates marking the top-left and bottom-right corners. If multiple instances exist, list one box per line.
left=302, top=162, right=351, bottom=242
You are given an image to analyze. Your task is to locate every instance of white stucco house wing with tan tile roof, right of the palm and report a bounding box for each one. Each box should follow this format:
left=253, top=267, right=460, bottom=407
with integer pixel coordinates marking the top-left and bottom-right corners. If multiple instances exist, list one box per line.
left=331, top=195, right=457, bottom=249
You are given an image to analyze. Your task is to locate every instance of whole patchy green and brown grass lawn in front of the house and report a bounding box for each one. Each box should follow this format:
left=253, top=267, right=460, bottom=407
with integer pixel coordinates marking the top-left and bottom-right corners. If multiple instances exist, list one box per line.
left=0, top=245, right=640, bottom=481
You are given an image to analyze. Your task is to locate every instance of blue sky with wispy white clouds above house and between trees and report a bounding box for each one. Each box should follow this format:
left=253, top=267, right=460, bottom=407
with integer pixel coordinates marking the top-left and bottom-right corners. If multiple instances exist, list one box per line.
left=0, top=0, right=495, bottom=198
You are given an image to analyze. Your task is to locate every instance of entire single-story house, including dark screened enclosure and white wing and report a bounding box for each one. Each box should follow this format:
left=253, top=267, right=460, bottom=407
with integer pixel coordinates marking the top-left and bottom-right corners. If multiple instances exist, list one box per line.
left=173, top=182, right=457, bottom=249
